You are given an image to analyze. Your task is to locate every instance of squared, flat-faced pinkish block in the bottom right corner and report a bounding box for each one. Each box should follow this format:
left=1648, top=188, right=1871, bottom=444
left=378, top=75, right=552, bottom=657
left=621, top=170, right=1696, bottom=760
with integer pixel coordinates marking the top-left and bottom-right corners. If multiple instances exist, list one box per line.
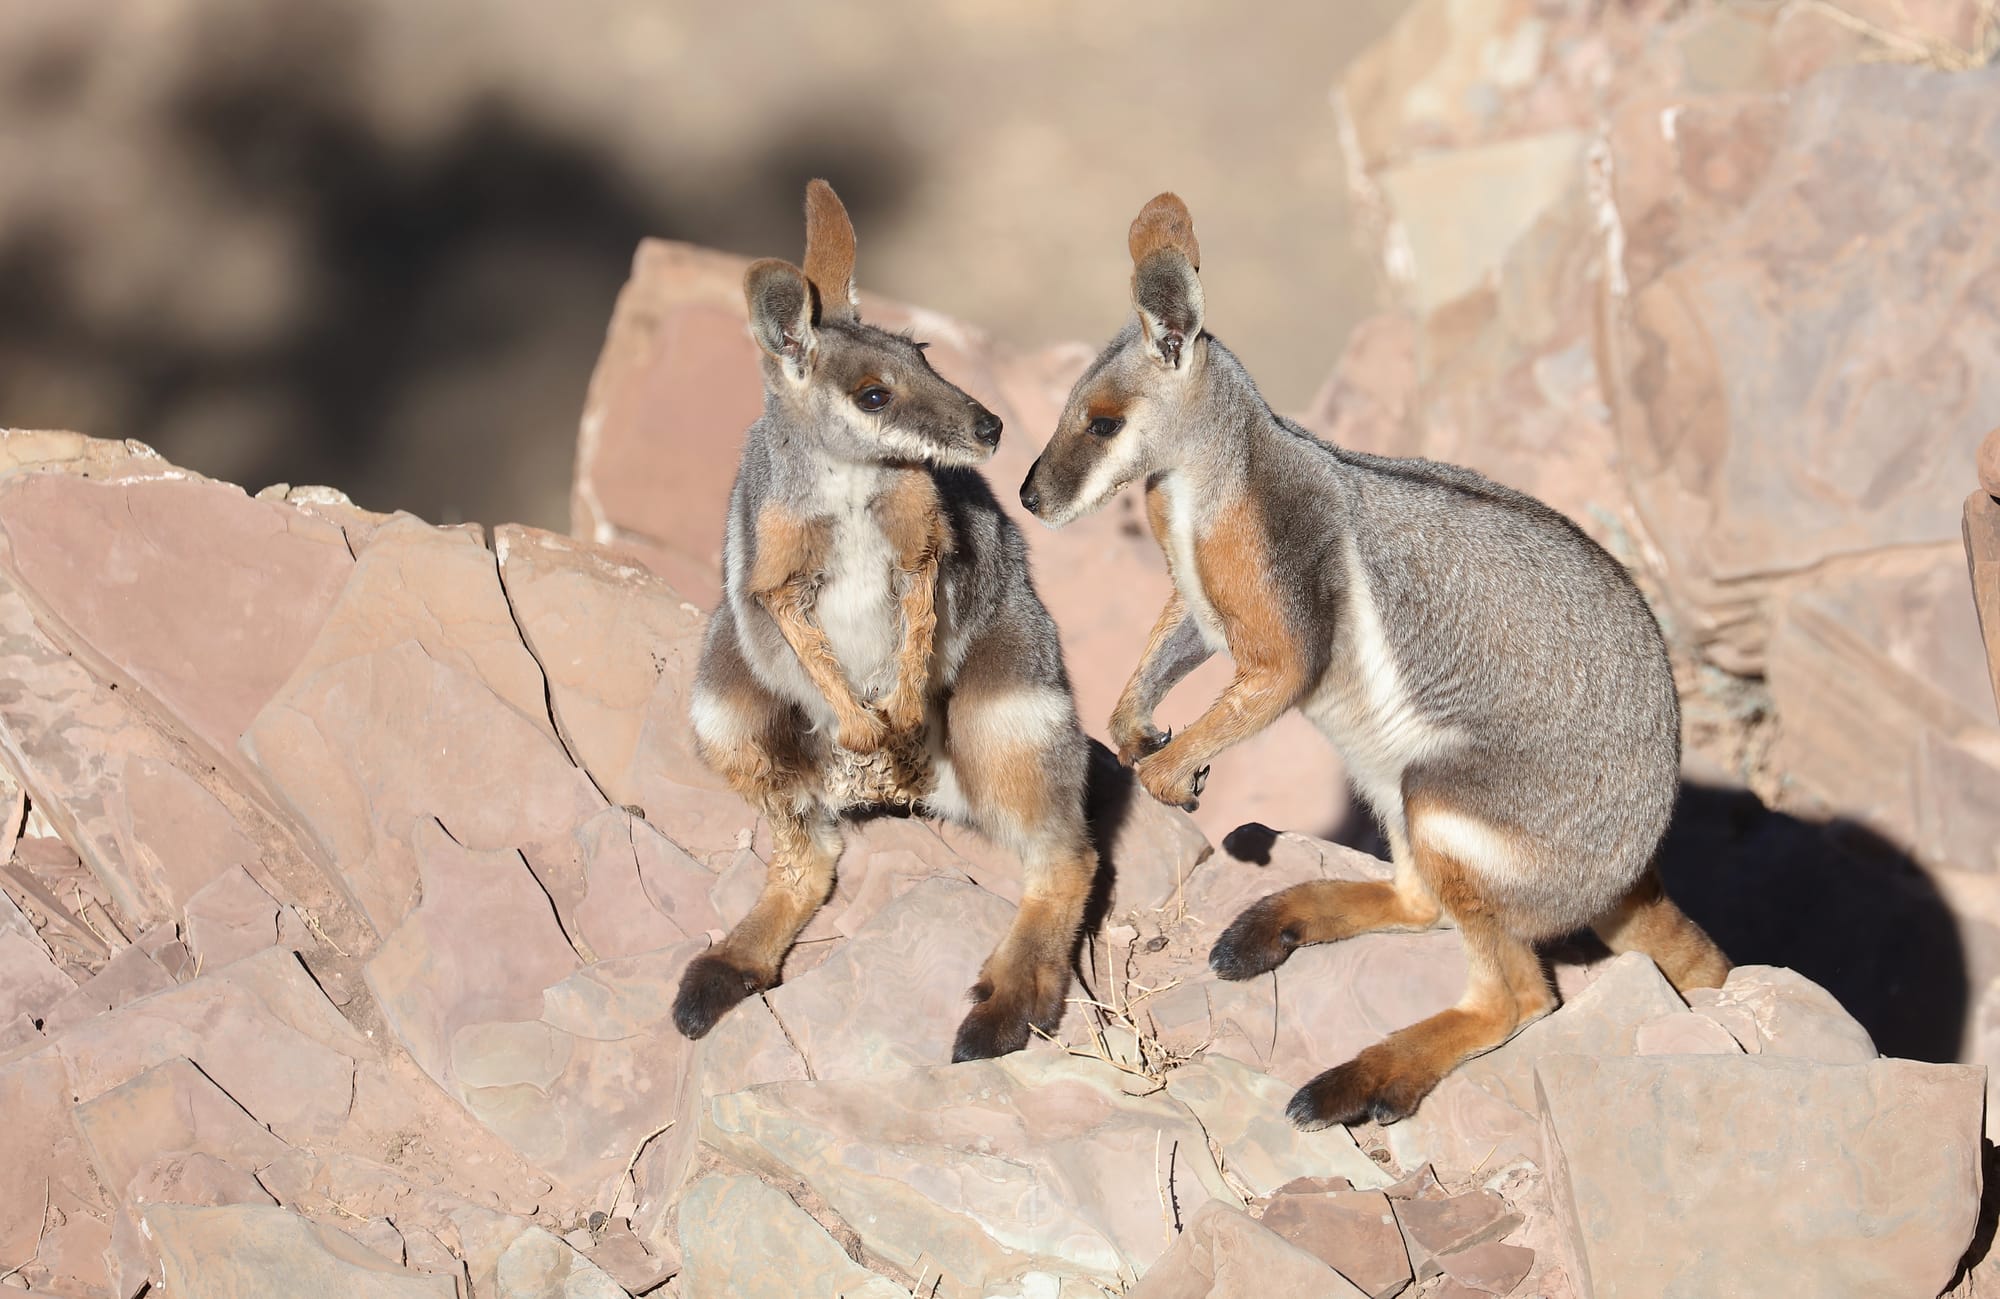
left=1536, top=1055, right=1984, bottom=1299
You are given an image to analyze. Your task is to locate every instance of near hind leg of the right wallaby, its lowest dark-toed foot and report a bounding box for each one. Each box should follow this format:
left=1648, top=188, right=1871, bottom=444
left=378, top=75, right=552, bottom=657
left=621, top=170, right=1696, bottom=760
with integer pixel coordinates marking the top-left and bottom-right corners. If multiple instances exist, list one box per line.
left=1286, top=815, right=1556, bottom=1127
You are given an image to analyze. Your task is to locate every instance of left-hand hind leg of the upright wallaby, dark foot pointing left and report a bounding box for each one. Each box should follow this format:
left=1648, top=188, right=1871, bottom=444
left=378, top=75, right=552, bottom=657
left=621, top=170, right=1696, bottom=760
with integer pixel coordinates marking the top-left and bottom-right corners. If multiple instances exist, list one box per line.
left=674, top=805, right=842, bottom=1037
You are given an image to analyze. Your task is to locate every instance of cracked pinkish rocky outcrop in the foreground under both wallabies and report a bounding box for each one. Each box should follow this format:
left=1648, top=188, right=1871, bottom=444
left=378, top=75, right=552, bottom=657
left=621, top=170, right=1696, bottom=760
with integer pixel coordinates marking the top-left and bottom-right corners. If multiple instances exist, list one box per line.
left=0, top=434, right=1980, bottom=1299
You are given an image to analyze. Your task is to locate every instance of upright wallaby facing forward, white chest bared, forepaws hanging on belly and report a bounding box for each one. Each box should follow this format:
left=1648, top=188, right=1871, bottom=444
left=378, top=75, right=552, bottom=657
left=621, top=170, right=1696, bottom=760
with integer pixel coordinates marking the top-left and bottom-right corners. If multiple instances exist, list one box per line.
left=674, top=180, right=1098, bottom=1059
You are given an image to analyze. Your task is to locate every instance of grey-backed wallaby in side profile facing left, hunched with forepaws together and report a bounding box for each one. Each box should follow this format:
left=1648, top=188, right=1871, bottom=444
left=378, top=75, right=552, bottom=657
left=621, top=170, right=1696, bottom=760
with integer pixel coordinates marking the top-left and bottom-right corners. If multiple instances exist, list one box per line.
left=1020, top=194, right=1730, bottom=1127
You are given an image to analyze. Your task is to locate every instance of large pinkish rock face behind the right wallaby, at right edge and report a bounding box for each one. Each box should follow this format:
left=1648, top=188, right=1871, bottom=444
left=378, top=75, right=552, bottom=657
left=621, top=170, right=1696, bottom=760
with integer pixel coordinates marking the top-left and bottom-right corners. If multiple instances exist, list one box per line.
left=1604, top=64, right=2000, bottom=671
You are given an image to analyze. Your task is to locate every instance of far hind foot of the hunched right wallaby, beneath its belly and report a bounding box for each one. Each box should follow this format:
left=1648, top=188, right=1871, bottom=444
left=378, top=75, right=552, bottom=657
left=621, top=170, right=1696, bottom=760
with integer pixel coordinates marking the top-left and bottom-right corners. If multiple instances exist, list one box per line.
left=1208, top=827, right=1442, bottom=979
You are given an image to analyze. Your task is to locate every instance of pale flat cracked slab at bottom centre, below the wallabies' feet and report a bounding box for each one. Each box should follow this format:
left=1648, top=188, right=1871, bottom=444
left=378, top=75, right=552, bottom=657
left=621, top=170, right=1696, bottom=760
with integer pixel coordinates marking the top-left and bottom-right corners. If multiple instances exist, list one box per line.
left=702, top=1051, right=1242, bottom=1295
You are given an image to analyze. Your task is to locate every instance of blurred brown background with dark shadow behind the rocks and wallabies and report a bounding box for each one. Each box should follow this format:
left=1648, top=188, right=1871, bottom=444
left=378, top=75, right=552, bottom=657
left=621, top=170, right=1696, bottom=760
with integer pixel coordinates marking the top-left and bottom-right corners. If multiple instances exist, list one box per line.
left=0, top=0, right=1404, bottom=528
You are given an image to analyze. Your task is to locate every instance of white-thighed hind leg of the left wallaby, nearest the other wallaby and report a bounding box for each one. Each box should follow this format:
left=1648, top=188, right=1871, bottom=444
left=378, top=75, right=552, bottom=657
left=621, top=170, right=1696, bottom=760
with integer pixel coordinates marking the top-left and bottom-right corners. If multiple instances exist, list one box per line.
left=950, top=679, right=1098, bottom=1061
